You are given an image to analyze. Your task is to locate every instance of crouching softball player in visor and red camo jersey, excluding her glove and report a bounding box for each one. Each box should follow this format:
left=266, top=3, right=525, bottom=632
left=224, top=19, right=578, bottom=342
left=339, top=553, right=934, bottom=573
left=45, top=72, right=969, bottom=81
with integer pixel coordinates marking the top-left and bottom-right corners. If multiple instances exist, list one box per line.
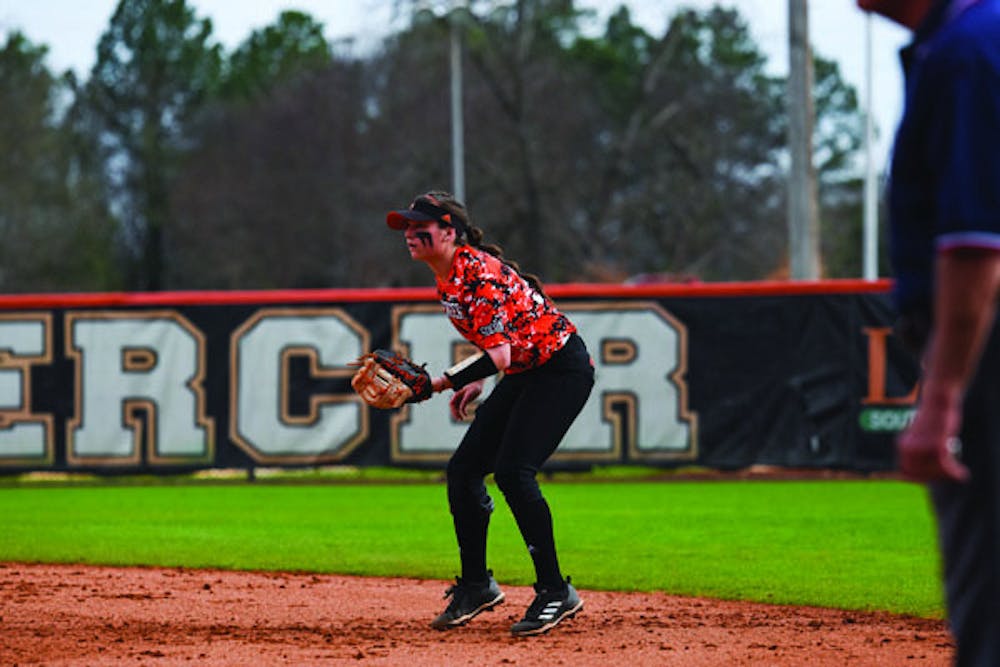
left=386, top=192, right=594, bottom=635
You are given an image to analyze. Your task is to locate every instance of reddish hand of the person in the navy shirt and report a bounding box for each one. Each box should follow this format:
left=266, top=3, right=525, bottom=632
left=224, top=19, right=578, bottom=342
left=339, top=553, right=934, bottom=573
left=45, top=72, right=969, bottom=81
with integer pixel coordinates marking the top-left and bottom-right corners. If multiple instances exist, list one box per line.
left=896, top=393, right=969, bottom=482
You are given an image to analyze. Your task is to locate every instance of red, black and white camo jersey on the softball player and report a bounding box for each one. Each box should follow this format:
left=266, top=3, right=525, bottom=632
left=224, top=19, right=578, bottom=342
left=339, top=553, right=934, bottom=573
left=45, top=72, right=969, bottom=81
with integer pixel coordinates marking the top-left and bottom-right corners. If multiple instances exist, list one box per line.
left=437, top=246, right=576, bottom=374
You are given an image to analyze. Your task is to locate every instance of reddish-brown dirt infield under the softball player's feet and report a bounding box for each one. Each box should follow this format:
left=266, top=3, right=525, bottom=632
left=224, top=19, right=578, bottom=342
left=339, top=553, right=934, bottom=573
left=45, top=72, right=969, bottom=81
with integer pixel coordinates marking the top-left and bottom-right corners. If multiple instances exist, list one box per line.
left=0, top=563, right=953, bottom=667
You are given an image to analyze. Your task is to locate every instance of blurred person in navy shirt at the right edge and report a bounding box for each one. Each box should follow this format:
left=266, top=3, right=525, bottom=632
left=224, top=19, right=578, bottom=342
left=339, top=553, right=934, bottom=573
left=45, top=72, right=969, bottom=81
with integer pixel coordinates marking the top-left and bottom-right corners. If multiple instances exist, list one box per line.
left=857, top=0, right=1000, bottom=666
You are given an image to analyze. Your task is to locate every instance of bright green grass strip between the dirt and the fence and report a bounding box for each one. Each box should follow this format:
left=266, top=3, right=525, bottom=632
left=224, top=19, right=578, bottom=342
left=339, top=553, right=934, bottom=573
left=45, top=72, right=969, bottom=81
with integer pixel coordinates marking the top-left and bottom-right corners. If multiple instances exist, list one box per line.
left=0, top=480, right=943, bottom=618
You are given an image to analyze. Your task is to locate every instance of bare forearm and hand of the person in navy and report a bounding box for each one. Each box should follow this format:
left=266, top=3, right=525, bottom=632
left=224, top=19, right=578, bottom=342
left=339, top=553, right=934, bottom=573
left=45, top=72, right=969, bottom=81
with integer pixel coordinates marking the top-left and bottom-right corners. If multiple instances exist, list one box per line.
left=897, top=248, right=1000, bottom=482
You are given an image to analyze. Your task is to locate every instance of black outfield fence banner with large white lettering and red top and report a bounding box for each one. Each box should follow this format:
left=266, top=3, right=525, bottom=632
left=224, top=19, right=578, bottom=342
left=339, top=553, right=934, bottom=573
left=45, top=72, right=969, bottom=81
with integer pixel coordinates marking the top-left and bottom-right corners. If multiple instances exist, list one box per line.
left=0, top=281, right=918, bottom=474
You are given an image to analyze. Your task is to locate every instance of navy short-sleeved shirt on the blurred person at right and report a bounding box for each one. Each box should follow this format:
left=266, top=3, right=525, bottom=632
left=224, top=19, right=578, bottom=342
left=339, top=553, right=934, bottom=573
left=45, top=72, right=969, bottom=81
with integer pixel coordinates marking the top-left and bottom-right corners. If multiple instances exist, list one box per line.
left=889, top=0, right=1000, bottom=313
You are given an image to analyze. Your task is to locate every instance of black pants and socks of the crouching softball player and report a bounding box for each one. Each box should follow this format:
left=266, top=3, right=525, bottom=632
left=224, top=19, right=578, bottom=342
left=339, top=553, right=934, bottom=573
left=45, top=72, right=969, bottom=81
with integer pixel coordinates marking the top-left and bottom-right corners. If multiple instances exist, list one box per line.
left=448, top=334, right=594, bottom=586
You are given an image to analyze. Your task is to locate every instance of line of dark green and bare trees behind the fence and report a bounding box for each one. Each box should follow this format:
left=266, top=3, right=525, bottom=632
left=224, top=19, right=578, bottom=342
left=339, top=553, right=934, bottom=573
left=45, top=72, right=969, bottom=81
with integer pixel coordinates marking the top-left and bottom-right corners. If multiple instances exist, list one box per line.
left=0, top=0, right=876, bottom=292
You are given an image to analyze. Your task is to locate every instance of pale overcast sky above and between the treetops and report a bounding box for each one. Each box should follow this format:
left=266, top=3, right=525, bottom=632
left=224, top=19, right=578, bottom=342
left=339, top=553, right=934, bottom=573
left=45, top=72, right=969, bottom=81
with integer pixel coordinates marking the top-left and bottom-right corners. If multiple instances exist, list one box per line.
left=0, top=0, right=907, bottom=167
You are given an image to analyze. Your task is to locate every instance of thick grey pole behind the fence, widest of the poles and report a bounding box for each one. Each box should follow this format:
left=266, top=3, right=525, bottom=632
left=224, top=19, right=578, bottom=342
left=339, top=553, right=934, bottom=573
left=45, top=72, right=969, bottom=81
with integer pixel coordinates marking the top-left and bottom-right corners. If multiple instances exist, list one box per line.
left=788, top=0, right=819, bottom=280
